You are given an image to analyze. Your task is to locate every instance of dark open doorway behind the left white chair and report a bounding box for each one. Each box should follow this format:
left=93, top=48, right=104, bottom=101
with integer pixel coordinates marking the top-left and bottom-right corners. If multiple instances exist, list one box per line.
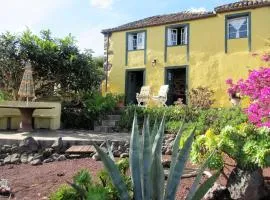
left=125, top=69, right=145, bottom=104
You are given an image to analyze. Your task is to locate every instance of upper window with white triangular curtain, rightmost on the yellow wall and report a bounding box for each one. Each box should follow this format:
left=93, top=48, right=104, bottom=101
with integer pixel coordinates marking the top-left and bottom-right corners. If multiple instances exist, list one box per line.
left=227, top=16, right=249, bottom=39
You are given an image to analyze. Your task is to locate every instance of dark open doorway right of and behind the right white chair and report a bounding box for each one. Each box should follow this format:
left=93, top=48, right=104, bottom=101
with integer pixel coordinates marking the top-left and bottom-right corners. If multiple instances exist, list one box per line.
left=165, top=67, right=188, bottom=105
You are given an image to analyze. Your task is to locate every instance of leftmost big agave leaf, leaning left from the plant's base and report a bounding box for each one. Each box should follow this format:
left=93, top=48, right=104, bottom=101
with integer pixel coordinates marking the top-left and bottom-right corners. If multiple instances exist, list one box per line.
left=94, top=143, right=129, bottom=200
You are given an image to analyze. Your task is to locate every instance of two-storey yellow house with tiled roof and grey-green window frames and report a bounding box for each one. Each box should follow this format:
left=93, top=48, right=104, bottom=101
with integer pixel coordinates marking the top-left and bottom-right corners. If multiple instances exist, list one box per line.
left=102, top=0, right=270, bottom=106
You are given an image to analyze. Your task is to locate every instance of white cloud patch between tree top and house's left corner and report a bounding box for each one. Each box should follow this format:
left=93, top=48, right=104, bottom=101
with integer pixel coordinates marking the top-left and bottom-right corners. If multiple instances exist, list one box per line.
left=76, top=26, right=104, bottom=56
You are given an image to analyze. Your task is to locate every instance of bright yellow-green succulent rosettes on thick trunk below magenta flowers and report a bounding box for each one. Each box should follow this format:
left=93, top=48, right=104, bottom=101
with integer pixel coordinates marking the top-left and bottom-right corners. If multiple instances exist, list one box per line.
left=191, top=123, right=270, bottom=170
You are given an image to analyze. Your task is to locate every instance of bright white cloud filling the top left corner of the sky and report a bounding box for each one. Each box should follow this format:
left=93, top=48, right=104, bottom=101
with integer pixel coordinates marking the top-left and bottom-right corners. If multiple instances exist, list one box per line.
left=0, top=0, right=67, bottom=32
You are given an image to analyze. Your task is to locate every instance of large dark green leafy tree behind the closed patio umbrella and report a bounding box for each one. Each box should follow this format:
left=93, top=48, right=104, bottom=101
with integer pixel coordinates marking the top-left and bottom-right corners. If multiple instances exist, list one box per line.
left=0, top=30, right=104, bottom=99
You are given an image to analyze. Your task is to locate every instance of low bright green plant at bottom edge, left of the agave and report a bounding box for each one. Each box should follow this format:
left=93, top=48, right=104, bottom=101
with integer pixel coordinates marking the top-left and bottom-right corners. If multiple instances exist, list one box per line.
left=50, top=169, right=110, bottom=200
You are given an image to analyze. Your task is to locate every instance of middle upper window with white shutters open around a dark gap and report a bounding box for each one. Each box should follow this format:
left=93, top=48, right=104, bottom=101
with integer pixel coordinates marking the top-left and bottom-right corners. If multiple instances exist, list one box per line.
left=167, top=26, right=187, bottom=46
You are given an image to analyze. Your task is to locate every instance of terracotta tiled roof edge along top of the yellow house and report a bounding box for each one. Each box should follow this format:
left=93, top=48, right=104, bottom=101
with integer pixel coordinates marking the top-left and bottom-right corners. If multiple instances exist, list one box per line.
left=102, top=0, right=270, bottom=33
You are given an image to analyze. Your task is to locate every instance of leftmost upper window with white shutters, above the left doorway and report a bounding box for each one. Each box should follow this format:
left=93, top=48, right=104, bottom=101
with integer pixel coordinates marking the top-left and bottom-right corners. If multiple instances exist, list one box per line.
left=128, top=32, right=145, bottom=51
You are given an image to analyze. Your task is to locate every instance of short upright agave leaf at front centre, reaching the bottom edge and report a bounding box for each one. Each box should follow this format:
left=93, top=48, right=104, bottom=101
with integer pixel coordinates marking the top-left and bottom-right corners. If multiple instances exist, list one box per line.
left=151, top=154, right=165, bottom=200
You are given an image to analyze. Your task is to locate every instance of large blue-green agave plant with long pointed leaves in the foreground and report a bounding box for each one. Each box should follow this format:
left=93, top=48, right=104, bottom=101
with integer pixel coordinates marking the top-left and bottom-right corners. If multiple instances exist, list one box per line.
left=94, top=114, right=219, bottom=200
